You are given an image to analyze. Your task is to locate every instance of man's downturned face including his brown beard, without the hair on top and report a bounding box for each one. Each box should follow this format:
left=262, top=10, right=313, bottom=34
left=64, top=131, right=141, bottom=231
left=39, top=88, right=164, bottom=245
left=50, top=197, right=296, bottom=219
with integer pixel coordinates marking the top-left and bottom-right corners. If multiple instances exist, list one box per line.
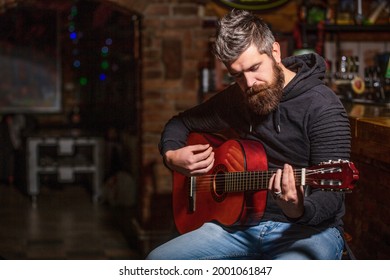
left=229, top=45, right=284, bottom=115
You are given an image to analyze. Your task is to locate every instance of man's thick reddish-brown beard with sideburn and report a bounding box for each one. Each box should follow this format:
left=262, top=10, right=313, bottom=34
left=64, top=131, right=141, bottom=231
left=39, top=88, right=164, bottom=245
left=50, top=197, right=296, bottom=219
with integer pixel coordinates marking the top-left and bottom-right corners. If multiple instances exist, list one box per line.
left=245, top=62, right=284, bottom=116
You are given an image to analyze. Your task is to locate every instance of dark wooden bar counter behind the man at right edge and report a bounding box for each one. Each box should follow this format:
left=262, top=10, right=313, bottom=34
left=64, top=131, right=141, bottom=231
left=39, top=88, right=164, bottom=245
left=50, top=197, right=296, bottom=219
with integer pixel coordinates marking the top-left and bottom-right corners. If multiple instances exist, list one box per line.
left=344, top=103, right=390, bottom=260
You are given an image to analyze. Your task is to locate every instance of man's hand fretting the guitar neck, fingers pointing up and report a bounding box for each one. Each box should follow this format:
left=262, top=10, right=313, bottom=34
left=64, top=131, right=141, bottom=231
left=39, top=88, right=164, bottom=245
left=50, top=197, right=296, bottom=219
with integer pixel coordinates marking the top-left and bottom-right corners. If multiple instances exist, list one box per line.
left=268, top=164, right=304, bottom=219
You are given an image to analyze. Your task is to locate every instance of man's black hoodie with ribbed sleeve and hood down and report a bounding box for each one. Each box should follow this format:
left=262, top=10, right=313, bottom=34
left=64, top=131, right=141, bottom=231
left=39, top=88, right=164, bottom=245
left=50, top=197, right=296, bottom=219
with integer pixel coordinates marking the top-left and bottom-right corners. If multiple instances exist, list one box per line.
left=159, top=54, right=351, bottom=229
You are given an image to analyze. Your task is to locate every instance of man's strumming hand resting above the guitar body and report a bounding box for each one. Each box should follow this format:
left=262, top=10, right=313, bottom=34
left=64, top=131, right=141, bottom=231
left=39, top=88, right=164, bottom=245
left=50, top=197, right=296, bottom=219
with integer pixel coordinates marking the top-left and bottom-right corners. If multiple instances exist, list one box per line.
left=164, top=144, right=215, bottom=176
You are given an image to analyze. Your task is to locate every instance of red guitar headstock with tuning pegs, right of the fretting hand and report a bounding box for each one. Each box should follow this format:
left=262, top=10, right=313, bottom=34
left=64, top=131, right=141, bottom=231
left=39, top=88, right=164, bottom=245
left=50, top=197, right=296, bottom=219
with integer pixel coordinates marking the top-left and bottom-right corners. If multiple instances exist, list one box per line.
left=305, top=160, right=359, bottom=192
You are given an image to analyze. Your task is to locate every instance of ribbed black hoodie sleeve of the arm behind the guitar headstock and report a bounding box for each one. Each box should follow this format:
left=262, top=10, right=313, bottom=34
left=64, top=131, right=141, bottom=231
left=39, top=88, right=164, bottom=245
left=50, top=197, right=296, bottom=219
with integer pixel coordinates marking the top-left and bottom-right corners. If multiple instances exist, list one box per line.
left=299, top=88, right=351, bottom=225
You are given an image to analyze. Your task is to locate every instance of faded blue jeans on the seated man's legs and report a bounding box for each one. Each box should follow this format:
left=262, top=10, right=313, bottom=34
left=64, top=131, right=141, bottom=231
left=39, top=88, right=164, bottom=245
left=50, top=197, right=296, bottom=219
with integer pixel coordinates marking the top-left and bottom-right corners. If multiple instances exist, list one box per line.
left=147, top=221, right=344, bottom=260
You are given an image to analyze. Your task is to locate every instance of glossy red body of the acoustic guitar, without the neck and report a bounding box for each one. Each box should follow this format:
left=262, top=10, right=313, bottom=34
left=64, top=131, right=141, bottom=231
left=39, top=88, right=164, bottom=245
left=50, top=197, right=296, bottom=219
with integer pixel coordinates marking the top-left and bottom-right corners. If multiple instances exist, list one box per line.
left=172, top=133, right=268, bottom=233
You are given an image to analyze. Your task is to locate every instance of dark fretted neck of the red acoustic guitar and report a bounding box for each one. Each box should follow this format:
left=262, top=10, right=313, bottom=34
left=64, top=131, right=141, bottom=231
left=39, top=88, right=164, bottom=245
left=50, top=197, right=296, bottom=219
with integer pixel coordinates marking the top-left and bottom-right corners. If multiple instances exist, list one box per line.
left=222, top=168, right=306, bottom=192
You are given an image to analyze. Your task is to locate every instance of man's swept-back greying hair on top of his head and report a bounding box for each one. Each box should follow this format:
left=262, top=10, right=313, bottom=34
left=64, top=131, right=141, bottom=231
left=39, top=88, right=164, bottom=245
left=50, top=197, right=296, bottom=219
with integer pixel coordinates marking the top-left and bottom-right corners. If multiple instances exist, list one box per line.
left=214, top=10, right=275, bottom=64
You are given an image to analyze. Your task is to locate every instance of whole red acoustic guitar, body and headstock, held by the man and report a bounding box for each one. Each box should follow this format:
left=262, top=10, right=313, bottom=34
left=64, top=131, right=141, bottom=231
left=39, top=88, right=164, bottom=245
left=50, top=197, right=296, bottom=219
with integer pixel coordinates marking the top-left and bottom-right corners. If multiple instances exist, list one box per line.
left=173, top=133, right=359, bottom=233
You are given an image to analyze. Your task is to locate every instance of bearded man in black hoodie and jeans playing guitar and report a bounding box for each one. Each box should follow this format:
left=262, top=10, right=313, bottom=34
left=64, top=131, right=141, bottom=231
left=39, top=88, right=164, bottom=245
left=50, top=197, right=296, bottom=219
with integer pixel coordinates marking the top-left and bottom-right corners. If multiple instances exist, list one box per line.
left=147, top=10, right=351, bottom=259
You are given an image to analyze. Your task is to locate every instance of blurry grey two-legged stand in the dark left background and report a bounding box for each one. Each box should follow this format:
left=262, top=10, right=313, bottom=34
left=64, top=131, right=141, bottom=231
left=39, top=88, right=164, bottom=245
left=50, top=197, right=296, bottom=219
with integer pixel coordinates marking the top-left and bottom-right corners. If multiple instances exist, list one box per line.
left=27, top=135, right=103, bottom=202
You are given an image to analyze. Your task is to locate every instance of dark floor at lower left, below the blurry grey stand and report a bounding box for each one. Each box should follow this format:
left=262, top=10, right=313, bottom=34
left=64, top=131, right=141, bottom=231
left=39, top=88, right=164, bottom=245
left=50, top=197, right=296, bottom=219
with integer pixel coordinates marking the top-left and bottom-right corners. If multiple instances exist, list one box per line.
left=0, top=185, right=140, bottom=260
